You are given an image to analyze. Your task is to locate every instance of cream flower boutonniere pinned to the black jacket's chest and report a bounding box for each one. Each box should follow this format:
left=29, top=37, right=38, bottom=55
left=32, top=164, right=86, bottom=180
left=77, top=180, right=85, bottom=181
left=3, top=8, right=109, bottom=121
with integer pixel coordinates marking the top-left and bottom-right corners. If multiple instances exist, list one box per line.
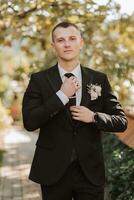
left=87, top=84, right=102, bottom=100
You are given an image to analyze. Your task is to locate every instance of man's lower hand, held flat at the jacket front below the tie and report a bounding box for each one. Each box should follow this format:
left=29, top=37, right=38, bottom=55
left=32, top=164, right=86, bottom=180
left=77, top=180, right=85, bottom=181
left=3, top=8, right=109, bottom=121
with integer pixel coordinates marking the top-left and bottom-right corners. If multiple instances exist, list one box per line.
left=70, top=106, right=94, bottom=123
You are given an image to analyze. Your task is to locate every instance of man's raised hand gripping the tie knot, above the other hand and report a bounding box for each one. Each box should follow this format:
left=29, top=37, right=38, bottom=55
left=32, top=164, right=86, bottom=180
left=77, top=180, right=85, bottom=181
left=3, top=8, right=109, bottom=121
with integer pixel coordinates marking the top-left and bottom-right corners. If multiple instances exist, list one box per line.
left=60, top=76, right=81, bottom=97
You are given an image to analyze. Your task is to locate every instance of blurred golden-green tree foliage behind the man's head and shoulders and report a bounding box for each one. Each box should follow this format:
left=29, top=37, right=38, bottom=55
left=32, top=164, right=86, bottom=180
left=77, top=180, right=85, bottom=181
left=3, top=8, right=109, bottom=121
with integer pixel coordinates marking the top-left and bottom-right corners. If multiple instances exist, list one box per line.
left=0, top=0, right=134, bottom=103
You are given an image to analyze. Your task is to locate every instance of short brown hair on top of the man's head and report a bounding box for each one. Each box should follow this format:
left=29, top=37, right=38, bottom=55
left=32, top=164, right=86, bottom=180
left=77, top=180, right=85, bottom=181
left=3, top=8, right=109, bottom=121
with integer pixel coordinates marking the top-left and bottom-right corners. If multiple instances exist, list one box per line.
left=52, top=22, right=81, bottom=41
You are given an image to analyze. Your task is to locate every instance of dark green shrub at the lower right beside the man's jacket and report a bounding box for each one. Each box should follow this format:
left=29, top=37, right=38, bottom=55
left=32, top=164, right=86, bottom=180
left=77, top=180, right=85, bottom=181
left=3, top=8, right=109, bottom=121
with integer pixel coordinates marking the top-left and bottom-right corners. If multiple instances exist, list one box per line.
left=103, top=134, right=134, bottom=200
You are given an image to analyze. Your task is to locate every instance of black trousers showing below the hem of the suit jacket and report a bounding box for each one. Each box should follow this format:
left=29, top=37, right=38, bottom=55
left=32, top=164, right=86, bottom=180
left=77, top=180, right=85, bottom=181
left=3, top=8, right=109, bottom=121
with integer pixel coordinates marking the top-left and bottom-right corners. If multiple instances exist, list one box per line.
left=41, top=161, right=104, bottom=200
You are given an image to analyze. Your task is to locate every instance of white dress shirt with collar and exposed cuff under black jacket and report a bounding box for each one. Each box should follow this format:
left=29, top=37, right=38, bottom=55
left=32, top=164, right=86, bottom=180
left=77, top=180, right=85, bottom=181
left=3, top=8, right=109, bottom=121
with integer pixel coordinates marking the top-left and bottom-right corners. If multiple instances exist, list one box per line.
left=56, top=64, right=82, bottom=105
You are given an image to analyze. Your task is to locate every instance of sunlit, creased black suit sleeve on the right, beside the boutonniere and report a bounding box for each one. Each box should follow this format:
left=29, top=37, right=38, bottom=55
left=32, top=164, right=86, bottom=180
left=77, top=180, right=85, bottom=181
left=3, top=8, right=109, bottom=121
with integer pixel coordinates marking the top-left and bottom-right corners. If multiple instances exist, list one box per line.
left=95, top=76, right=127, bottom=132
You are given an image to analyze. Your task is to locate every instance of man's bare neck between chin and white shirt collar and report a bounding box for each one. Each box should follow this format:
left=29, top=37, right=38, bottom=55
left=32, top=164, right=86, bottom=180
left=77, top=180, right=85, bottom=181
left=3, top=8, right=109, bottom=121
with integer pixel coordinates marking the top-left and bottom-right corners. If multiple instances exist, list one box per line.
left=58, top=59, right=80, bottom=72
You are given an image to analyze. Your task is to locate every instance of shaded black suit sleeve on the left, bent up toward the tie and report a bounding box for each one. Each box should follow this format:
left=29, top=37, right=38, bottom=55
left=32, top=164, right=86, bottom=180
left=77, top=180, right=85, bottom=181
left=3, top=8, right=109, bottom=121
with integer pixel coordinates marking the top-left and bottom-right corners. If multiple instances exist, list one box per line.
left=22, top=74, right=64, bottom=131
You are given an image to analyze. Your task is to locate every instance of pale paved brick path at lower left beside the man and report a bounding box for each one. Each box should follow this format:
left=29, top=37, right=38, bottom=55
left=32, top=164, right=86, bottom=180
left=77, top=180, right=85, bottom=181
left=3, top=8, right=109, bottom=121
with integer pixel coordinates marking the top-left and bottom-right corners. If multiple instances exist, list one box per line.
left=0, top=127, right=41, bottom=200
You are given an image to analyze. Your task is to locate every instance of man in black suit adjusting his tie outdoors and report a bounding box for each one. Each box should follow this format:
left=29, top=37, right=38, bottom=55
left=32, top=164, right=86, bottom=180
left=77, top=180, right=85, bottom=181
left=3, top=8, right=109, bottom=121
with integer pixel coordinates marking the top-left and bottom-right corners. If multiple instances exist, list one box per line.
left=23, top=22, right=127, bottom=200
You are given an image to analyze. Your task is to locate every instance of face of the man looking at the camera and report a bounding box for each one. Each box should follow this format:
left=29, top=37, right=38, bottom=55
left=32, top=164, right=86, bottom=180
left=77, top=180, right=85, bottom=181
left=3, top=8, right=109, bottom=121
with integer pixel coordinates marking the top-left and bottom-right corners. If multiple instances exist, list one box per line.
left=52, top=26, right=83, bottom=61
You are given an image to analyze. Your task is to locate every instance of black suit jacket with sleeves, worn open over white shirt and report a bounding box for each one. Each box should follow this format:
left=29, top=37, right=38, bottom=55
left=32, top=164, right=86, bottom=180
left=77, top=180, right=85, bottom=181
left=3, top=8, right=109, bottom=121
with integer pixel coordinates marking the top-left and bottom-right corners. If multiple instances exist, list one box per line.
left=22, top=65, right=127, bottom=185
